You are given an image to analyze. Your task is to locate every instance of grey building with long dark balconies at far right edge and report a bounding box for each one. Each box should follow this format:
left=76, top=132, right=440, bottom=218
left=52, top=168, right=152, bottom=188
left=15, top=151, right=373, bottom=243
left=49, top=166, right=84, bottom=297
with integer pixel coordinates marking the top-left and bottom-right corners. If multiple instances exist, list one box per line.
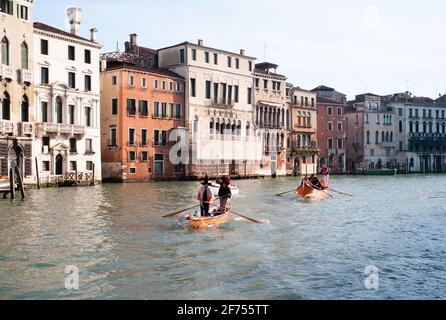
left=386, top=93, right=446, bottom=173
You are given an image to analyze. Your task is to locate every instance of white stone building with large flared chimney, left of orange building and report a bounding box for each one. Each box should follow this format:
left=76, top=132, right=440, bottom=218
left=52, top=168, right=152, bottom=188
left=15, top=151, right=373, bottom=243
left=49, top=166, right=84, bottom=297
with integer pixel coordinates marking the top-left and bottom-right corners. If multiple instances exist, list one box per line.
left=34, top=8, right=101, bottom=181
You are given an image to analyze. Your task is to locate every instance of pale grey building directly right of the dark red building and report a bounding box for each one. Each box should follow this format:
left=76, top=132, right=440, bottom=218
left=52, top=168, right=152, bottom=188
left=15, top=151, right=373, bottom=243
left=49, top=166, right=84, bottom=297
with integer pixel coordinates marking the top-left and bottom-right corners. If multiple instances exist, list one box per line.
left=346, top=93, right=398, bottom=172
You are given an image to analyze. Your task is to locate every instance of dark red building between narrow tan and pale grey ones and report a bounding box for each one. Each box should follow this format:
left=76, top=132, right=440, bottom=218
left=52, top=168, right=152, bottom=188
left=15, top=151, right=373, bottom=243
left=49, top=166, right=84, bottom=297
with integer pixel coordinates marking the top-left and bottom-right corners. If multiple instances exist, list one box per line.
left=312, top=86, right=347, bottom=173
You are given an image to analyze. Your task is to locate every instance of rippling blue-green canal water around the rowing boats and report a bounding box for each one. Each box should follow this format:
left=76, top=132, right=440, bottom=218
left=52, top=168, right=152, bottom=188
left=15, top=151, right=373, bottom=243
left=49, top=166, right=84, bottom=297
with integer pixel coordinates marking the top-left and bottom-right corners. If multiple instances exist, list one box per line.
left=0, top=175, right=446, bottom=299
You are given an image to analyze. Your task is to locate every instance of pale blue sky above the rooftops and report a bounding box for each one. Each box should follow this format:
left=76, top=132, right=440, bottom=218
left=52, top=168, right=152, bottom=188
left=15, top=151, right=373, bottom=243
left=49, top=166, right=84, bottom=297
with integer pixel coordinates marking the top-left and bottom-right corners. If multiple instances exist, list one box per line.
left=34, top=0, right=446, bottom=99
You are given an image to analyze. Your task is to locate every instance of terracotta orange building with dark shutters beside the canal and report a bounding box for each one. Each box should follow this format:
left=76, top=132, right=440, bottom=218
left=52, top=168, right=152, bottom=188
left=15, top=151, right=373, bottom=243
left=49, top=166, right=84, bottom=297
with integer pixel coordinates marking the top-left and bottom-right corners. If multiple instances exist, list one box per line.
left=101, top=52, right=185, bottom=182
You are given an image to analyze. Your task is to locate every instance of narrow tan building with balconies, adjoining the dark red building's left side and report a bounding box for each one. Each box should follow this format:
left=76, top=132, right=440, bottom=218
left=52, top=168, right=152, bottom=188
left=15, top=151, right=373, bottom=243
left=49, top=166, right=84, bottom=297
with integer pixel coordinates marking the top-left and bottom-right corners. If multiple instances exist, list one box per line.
left=288, top=87, right=319, bottom=175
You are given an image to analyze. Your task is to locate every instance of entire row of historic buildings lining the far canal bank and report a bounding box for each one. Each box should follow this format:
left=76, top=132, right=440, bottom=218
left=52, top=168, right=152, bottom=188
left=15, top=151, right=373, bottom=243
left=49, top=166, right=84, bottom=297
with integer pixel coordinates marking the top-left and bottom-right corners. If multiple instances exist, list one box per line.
left=0, top=0, right=446, bottom=183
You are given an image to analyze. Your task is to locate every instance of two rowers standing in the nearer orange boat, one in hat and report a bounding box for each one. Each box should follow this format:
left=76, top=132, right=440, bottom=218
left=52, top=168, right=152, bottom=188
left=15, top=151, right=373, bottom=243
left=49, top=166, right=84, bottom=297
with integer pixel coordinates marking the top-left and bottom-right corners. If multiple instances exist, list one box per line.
left=197, top=175, right=232, bottom=217
